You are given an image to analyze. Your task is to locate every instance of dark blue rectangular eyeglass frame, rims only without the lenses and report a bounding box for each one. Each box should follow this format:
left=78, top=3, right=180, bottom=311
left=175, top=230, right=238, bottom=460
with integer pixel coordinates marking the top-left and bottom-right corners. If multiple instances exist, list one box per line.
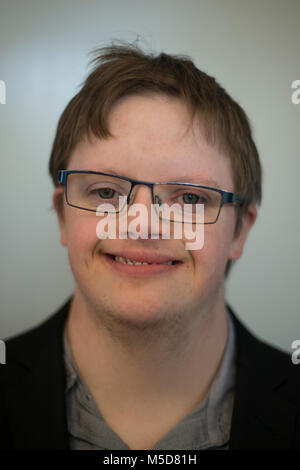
left=57, top=170, right=243, bottom=224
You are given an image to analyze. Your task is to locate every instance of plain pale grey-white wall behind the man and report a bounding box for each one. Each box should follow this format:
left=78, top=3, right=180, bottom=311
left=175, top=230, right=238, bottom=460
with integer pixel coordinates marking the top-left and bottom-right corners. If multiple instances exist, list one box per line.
left=0, top=0, right=300, bottom=352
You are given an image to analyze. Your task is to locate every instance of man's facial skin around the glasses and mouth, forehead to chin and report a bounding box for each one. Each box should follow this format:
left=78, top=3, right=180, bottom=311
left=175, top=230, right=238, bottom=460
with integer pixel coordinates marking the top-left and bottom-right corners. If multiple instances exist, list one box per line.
left=54, top=95, right=255, bottom=325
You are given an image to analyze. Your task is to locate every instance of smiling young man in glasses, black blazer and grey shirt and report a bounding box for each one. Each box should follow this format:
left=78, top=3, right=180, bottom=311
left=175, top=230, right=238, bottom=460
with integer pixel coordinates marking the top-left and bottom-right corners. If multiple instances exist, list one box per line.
left=0, top=45, right=300, bottom=450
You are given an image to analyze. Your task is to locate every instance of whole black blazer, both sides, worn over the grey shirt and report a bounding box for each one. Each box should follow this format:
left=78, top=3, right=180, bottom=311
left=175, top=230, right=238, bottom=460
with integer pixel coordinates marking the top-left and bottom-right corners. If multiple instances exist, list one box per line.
left=0, top=299, right=300, bottom=450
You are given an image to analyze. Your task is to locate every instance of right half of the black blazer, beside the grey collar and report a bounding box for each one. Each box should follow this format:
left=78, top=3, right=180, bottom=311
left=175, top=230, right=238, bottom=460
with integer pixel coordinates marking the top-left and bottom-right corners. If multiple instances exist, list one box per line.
left=227, top=306, right=296, bottom=449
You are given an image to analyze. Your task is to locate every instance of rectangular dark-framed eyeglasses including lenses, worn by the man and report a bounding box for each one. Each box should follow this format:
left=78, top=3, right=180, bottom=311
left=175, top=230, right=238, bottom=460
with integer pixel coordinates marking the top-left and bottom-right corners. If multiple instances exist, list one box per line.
left=58, top=170, right=243, bottom=224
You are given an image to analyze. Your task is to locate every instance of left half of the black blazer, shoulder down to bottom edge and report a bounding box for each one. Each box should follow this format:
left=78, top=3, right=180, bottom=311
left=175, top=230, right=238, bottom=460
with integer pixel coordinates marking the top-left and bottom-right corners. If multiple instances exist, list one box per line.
left=0, top=299, right=71, bottom=449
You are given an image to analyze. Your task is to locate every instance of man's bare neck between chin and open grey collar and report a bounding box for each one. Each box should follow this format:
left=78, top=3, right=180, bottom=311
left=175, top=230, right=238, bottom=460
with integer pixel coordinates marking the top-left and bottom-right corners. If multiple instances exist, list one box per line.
left=66, top=288, right=228, bottom=413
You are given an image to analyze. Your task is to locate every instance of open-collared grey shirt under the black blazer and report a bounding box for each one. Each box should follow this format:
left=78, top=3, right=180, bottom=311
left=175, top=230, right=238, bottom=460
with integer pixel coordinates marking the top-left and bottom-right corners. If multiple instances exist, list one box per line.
left=63, top=310, right=235, bottom=450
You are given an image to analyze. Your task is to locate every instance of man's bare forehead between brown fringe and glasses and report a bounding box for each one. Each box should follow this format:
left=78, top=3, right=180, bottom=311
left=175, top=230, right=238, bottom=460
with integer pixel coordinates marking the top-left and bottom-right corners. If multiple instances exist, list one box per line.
left=68, top=95, right=233, bottom=191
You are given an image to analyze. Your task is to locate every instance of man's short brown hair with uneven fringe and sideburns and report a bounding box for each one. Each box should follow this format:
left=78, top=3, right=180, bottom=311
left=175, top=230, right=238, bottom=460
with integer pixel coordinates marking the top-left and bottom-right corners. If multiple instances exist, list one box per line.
left=49, top=42, right=262, bottom=276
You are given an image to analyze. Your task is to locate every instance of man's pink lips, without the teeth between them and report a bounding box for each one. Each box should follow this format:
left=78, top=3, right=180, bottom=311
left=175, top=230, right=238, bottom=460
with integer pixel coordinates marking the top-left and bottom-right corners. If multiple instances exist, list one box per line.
left=102, top=253, right=183, bottom=277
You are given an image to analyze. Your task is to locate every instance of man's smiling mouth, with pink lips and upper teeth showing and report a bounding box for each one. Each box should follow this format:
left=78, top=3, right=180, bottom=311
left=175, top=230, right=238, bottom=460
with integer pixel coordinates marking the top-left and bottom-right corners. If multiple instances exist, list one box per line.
left=104, top=253, right=183, bottom=276
